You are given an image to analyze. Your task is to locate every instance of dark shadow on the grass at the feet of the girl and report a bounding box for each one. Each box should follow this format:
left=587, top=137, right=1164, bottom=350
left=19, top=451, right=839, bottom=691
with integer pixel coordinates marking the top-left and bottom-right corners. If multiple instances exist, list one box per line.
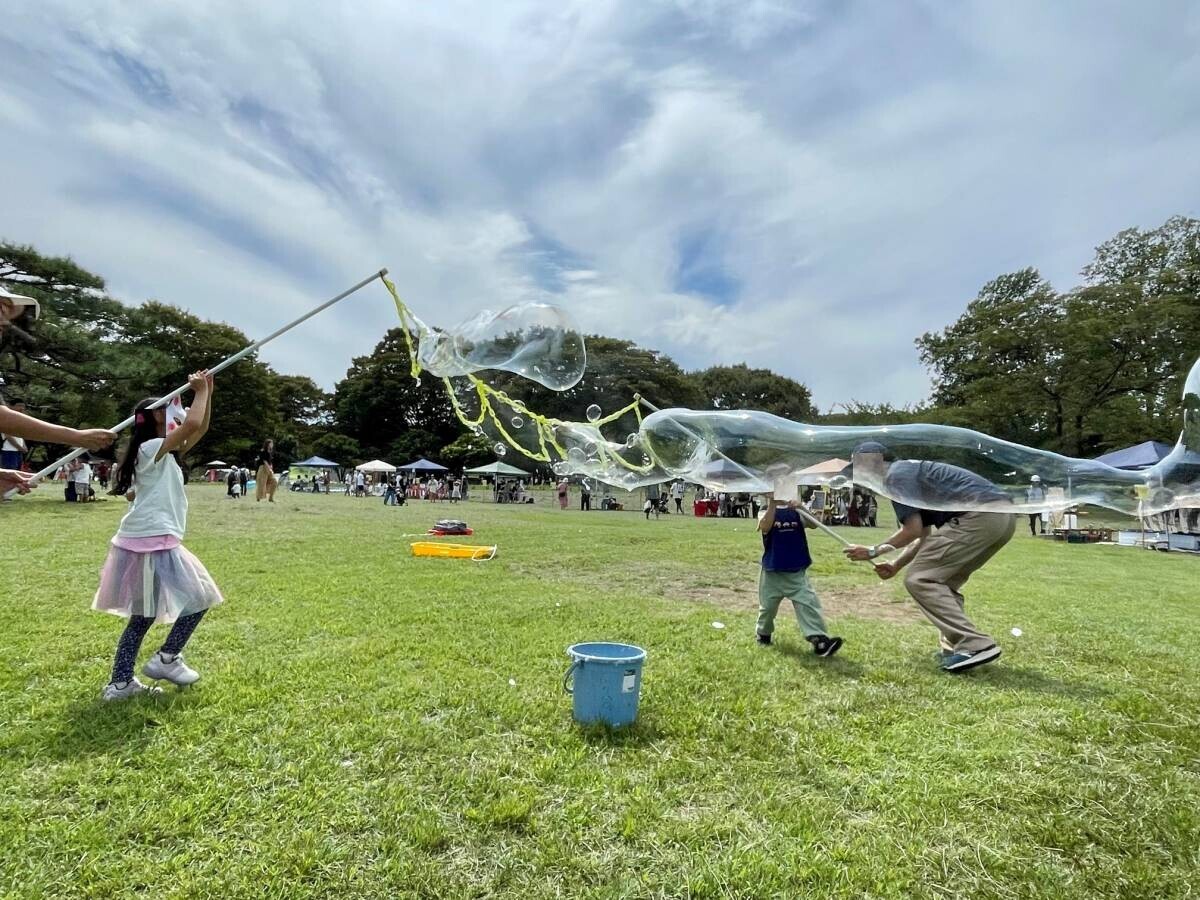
left=41, top=690, right=198, bottom=760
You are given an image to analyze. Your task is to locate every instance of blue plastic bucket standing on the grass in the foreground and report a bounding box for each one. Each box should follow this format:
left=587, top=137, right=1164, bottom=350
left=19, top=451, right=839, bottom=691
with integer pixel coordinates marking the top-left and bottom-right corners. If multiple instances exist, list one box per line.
left=563, top=642, right=646, bottom=727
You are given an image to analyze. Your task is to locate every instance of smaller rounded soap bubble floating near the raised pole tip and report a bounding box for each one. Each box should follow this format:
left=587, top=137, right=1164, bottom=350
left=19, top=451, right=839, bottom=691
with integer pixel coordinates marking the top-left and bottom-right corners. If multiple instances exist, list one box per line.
left=409, top=302, right=587, bottom=390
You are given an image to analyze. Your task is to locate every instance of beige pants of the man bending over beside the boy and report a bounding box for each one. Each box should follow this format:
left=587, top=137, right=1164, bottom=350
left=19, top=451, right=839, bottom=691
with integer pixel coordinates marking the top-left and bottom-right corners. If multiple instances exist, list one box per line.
left=904, top=512, right=1016, bottom=653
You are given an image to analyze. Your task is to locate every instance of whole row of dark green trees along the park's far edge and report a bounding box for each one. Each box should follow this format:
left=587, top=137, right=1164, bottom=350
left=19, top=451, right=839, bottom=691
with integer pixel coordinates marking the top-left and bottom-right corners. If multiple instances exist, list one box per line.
left=0, top=217, right=1200, bottom=475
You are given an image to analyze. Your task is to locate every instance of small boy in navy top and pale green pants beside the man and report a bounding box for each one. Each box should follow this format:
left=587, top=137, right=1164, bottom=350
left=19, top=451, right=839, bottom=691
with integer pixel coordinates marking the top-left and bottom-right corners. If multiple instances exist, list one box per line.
left=757, top=493, right=842, bottom=656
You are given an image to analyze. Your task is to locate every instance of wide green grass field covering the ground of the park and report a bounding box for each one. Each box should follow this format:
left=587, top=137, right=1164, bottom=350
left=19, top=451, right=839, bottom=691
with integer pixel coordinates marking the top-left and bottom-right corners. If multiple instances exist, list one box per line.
left=0, top=486, right=1200, bottom=898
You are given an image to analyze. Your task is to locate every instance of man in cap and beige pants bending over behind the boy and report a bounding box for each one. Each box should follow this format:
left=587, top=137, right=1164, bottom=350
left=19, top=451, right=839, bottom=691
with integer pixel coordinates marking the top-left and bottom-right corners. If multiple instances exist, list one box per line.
left=845, top=442, right=1016, bottom=672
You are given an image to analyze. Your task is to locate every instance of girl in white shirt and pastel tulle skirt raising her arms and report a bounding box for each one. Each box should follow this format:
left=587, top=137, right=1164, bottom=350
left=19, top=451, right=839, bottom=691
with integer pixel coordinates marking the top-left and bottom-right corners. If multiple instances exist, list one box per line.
left=91, top=372, right=223, bottom=701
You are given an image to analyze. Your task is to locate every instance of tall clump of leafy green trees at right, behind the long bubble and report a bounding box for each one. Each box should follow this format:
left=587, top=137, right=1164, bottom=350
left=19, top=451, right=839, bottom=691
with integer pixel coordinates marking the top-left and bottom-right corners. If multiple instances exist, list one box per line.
left=917, top=218, right=1200, bottom=456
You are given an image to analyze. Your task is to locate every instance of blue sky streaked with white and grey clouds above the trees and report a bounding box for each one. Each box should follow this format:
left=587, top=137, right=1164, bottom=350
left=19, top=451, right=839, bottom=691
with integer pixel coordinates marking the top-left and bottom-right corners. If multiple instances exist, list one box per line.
left=0, top=0, right=1200, bottom=409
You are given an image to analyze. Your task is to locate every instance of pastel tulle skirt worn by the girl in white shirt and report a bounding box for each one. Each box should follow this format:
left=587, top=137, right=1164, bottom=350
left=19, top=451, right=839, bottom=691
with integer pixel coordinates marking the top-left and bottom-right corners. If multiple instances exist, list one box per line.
left=91, top=545, right=224, bottom=623
